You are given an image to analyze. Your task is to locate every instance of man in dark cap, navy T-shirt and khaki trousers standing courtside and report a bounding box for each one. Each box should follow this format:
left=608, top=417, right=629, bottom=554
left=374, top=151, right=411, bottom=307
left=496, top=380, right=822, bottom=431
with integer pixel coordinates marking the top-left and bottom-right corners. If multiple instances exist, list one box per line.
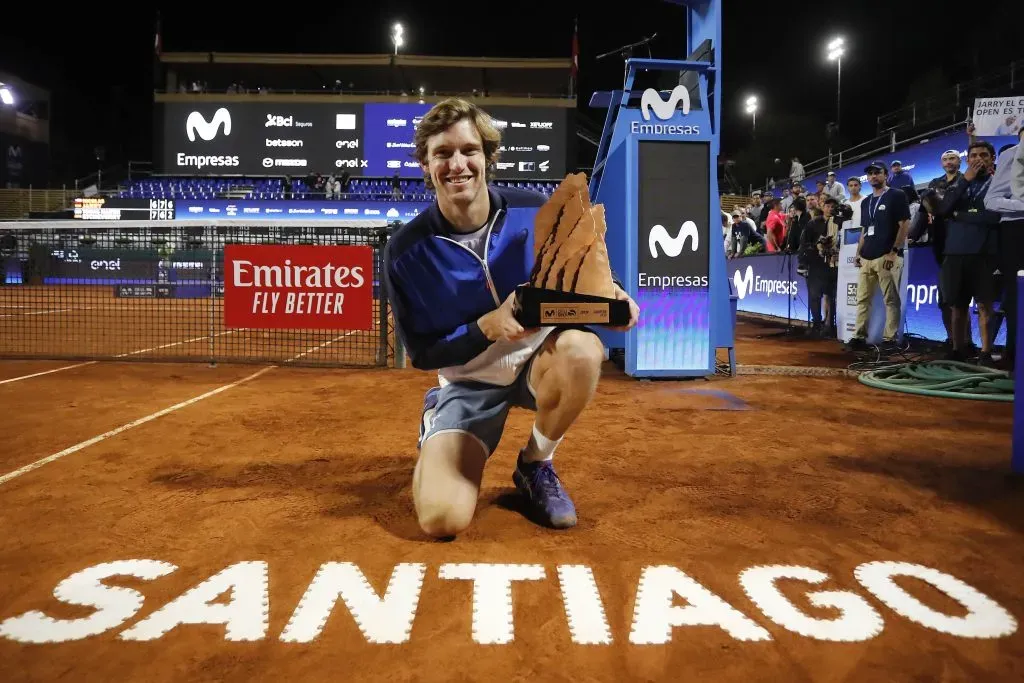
left=848, top=161, right=910, bottom=349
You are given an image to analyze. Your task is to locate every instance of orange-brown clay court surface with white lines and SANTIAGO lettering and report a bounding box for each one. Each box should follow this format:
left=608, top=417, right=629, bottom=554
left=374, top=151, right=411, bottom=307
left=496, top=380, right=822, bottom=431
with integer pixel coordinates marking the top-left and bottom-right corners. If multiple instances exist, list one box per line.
left=0, top=311, right=1024, bottom=683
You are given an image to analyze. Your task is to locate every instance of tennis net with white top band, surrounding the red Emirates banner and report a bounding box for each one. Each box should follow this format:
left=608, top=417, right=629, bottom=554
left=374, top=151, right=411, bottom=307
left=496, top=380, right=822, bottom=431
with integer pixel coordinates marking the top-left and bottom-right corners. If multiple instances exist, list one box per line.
left=0, top=220, right=394, bottom=367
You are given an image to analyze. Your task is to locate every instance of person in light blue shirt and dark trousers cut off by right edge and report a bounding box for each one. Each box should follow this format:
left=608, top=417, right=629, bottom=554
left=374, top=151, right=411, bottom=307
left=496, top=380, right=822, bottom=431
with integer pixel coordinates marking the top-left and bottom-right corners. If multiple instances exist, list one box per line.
left=985, top=128, right=1024, bottom=370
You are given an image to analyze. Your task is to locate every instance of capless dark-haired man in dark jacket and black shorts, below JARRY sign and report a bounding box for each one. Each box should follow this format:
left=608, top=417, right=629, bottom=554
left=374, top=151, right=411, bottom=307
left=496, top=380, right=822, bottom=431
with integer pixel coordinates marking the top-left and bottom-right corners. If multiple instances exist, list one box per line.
left=936, top=141, right=999, bottom=366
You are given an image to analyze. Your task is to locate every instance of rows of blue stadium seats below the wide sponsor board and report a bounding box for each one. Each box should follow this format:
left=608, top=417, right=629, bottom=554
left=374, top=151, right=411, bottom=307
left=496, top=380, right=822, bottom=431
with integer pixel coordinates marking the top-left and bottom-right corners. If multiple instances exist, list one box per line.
left=118, top=177, right=558, bottom=202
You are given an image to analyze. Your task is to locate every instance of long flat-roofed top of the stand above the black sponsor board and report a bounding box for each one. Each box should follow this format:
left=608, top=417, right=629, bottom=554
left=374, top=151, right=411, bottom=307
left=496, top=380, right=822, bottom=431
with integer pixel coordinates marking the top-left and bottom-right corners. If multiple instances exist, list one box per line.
left=158, top=52, right=575, bottom=106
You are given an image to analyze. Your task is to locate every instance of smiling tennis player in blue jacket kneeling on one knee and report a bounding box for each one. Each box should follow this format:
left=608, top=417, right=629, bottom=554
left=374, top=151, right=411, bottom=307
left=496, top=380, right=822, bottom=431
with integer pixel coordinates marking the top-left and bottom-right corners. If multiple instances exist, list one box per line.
left=384, top=98, right=640, bottom=538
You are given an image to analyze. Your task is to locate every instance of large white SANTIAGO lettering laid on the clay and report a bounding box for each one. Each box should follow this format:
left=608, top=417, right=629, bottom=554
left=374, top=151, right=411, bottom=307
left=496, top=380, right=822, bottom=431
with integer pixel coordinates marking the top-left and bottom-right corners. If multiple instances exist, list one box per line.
left=0, top=559, right=1018, bottom=651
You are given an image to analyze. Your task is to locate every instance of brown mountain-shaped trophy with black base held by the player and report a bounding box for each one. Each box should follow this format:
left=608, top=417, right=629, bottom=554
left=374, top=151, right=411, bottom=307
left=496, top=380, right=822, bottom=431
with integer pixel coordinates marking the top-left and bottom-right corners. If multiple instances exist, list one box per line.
left=513, top=173, right=630, bottom=329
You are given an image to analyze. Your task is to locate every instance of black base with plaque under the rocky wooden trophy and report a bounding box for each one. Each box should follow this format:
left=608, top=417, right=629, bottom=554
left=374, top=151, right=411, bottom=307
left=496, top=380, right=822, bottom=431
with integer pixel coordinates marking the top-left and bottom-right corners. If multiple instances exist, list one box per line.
left=513, top=285, right=630, bottom=329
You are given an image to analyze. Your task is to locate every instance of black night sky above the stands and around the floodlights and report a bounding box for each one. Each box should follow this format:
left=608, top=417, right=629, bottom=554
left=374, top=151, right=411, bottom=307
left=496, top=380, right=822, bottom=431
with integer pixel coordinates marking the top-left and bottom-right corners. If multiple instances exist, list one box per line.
left=0, top=0, right=1024, bottom=184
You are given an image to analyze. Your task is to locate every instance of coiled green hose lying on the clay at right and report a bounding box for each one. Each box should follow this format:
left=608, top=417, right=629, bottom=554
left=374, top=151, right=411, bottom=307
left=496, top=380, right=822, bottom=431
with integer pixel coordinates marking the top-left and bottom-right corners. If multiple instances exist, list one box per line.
left=858, top=360, right=1014, bottom=401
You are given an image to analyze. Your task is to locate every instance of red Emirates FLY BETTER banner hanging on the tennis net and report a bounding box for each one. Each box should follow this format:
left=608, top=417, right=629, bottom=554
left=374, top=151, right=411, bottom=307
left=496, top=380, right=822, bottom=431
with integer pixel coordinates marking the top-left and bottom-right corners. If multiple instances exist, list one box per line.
left=224, top=245, right=374, bottom=330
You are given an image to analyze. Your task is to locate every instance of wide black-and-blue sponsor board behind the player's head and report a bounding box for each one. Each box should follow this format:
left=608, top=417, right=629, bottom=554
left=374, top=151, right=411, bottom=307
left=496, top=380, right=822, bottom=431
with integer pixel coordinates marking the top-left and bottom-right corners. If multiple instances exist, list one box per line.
left=156, top=101, right=569, bottom=178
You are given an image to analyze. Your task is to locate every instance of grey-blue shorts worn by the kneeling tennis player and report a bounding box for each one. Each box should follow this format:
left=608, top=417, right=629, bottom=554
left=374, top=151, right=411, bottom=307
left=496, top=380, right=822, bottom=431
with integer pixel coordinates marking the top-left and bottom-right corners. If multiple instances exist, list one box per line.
left=417, top=355, right=537, bottom=457
